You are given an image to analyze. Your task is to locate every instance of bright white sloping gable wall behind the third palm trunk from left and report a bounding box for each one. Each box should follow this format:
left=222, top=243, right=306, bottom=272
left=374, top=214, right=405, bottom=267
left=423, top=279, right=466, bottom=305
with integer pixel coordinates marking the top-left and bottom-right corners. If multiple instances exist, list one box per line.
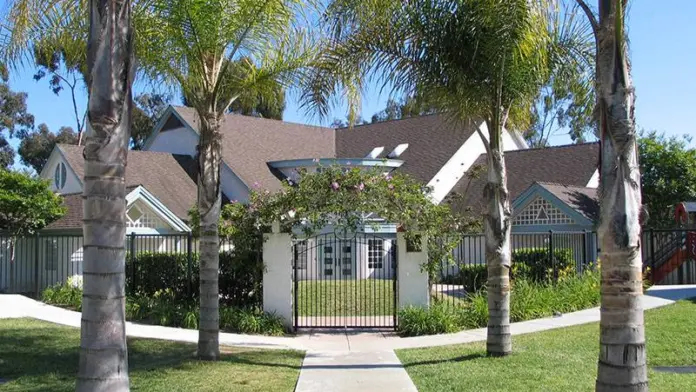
left=428, top=122, right=524, bottom=203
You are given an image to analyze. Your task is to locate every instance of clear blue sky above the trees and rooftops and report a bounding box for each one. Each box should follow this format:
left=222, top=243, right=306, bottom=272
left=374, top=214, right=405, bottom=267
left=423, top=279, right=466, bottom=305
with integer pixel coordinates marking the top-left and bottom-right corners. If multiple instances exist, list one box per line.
left=5, top=0, right=696, bottom=161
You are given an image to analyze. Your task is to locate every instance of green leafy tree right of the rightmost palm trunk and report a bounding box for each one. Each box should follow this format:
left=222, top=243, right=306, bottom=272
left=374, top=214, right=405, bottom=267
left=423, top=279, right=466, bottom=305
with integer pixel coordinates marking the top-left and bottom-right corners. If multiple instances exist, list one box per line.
left=638, top=131, right=696, bottom=228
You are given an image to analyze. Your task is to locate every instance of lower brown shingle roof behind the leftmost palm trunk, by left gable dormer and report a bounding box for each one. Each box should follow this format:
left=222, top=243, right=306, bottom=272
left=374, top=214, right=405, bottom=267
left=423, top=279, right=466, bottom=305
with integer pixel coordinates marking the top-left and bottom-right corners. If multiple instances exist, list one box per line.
left=58, top=144, right=197, bottom=220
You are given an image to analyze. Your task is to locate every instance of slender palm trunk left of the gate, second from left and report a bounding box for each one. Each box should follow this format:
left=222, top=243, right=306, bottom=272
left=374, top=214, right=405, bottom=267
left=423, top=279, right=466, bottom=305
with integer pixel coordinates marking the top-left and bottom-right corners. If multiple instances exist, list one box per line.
left=198, top=112, right=221, bottom=361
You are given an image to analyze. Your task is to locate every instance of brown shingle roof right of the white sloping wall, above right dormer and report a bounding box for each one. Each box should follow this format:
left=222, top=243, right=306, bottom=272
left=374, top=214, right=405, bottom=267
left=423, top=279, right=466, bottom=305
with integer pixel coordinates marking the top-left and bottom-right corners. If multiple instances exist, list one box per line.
left=450, top=143, right=599, bottom=214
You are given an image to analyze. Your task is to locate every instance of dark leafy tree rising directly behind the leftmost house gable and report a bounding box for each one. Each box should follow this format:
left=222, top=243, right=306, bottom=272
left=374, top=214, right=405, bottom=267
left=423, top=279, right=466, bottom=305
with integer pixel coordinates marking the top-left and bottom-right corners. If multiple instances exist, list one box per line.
left=17, top=124, right=78, bottom=173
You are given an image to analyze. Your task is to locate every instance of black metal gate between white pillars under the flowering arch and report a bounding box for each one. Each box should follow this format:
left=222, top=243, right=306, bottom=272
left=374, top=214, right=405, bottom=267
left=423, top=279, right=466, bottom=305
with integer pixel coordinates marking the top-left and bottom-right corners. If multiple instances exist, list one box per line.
left=293, top=233, right=398, bottom=329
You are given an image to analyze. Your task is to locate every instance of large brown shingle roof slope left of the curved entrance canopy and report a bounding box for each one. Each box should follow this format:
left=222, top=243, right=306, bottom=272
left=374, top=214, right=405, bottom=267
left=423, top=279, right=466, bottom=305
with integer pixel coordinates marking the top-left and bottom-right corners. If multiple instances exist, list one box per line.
left=174, top=106, right=336, bottom=190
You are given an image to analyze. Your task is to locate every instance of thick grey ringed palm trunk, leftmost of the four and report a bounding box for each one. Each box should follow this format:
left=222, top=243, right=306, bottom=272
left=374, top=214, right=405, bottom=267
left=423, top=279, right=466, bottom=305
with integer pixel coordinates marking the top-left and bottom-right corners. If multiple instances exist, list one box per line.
left=77, top=0, right=134, bottom=391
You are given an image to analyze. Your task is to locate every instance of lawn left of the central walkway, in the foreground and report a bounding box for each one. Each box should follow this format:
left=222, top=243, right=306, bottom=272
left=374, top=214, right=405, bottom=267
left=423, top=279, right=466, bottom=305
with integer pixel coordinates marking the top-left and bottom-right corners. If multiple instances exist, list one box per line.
left=0, top=319, right=304, bottom=392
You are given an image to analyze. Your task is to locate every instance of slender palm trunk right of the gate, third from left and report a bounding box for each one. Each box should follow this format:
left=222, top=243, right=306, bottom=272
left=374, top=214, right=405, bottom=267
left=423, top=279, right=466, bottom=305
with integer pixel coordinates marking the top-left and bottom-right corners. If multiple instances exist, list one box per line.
left=484, top=111, right=512, bottom=356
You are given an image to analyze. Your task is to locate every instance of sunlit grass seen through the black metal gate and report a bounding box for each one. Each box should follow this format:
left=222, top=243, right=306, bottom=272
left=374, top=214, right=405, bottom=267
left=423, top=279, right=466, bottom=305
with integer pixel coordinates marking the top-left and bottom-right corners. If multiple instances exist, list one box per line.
left=297, top=279, right=394, bottom=316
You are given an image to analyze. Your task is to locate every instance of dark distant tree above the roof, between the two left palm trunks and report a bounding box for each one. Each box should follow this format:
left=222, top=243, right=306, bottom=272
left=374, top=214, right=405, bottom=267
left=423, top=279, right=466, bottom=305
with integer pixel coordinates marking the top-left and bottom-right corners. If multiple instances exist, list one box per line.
left=130, top=93, right=171, bottom=150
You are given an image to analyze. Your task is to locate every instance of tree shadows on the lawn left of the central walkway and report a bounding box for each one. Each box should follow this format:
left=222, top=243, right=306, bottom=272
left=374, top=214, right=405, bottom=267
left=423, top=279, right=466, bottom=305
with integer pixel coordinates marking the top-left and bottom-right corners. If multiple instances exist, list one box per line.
left=0, top=321, right=304, bottom=380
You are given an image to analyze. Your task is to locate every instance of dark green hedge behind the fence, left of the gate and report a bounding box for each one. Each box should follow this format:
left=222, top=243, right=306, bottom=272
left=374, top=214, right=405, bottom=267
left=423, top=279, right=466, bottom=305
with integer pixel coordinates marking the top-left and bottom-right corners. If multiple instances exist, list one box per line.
left=126, top=251, right=263, bottom=308
